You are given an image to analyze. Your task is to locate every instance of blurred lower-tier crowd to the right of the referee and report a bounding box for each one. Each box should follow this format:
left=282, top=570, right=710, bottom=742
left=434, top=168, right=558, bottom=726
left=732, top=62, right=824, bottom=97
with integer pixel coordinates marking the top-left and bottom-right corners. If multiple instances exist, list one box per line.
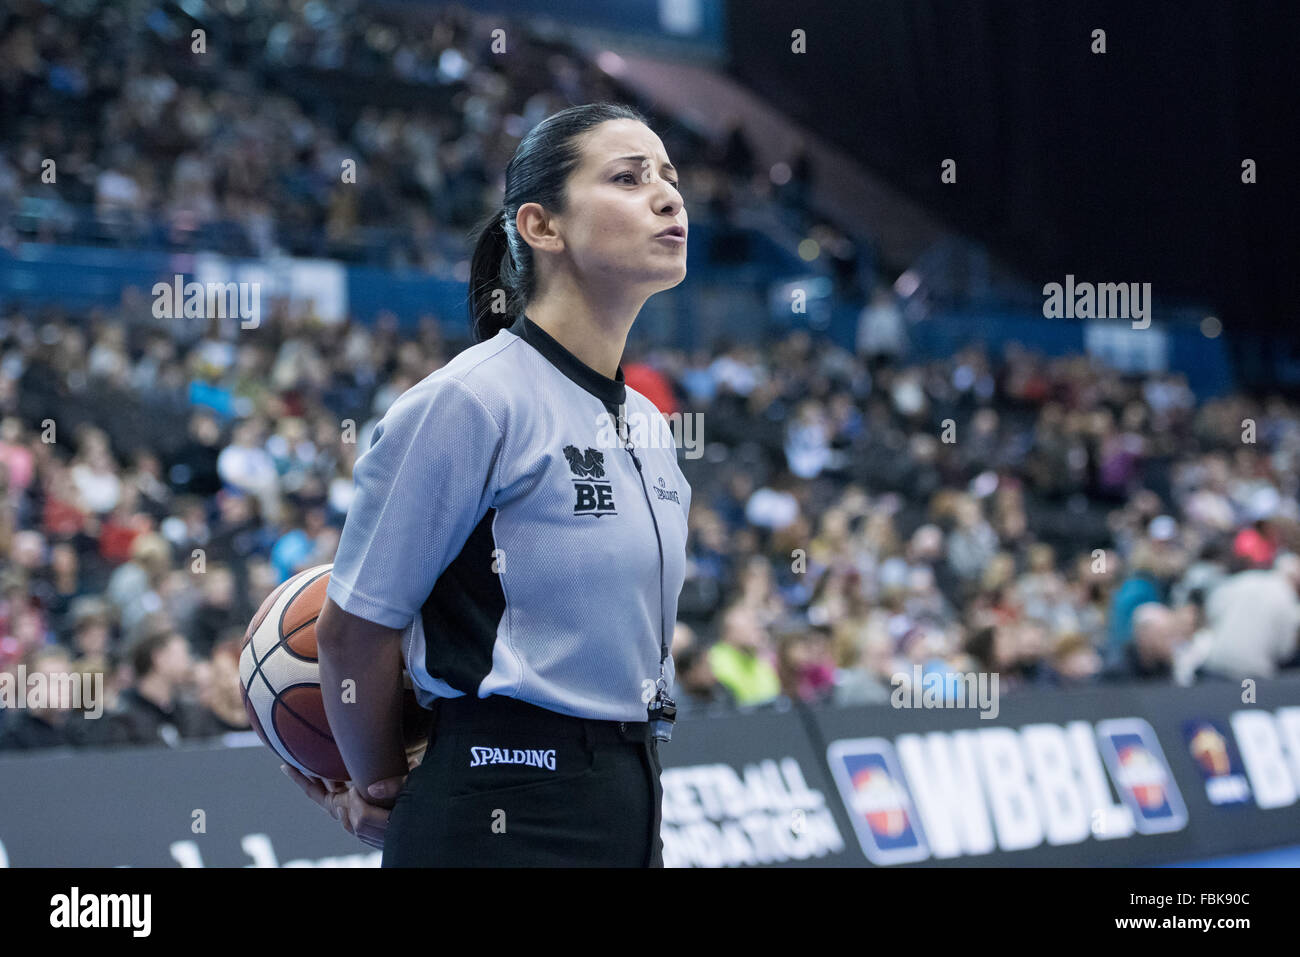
left=660, top=333, right=1300, bottom=709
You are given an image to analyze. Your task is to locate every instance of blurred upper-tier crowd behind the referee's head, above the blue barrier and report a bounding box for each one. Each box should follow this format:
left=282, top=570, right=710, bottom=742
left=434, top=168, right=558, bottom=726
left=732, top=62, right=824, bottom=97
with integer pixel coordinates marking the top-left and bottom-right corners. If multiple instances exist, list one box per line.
left=0, top=0, right=811, bottom=269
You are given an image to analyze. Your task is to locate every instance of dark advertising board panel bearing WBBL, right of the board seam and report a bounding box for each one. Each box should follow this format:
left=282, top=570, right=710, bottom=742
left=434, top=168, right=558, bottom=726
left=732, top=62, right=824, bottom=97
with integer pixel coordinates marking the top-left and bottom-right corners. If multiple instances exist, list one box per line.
left=813, top=680, right=1300, bottom=866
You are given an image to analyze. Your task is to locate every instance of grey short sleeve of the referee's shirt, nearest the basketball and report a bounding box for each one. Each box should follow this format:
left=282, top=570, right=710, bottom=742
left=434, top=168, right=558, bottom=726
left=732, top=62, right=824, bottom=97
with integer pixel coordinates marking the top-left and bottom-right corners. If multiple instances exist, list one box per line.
left=326, top=377, right=502, bottom=628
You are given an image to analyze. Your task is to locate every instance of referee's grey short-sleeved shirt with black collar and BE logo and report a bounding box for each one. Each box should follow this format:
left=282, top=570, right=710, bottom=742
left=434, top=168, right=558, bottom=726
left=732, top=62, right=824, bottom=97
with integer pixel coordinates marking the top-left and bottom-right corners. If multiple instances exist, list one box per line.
left=326, top=310, right=690, bottom=720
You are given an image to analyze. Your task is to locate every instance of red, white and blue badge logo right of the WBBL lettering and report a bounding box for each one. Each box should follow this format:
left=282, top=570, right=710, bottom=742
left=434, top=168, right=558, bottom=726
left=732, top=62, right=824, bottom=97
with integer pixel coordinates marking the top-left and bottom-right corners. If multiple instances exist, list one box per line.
left=1097, top=718, right=1187, bottom=833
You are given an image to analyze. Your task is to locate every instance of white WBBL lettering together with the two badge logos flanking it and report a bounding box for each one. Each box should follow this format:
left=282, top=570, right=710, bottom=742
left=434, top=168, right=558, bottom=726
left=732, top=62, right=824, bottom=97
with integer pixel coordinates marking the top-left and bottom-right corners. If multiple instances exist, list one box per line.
left=827, top=718, right=1187, bottom=865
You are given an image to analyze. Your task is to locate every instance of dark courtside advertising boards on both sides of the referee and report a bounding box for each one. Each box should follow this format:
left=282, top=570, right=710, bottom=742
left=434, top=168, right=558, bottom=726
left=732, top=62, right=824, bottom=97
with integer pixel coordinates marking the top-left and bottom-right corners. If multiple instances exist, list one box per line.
left=0, top=679, right=1300, bottom=867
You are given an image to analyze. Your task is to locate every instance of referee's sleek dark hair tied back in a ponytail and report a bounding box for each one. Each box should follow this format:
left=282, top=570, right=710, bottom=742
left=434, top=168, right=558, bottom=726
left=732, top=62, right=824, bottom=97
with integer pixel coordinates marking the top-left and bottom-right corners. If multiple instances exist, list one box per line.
left=467, top=103, right=646, bottom=342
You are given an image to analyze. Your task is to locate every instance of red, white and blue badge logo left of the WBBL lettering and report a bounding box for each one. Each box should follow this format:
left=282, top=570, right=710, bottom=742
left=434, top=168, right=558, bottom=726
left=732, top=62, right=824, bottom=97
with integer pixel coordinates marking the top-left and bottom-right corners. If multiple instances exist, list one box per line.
left=827, top=737, right=930, bottom=865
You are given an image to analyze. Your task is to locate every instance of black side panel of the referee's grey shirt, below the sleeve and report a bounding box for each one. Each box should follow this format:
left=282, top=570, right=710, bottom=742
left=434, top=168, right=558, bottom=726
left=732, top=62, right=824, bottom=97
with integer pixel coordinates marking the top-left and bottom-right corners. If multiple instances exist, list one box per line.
left=420, top=508, right=506, bottom=694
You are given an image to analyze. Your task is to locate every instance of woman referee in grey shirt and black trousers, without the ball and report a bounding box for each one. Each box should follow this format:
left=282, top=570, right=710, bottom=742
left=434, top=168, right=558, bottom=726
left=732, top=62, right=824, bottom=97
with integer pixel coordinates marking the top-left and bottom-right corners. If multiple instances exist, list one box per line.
left=283, top=103, right=690, bottom=867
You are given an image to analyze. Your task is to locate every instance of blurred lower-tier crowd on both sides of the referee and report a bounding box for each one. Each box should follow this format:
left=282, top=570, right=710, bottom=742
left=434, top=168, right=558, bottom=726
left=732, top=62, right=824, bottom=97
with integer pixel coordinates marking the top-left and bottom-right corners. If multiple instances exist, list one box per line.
left=0, top=291, right=1300, bottom=748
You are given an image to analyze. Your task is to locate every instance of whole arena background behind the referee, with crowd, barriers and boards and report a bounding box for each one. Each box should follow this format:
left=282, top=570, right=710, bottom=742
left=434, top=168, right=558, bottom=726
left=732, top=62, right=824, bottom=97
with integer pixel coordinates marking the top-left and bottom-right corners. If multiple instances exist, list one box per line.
left=0, top=0, right=1300, bottom=934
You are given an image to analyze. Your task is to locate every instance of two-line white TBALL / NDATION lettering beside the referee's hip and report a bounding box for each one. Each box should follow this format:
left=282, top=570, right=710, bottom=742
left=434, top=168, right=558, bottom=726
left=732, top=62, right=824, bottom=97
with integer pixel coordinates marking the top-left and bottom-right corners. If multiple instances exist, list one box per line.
left=659, top=757, right=845, bottom=867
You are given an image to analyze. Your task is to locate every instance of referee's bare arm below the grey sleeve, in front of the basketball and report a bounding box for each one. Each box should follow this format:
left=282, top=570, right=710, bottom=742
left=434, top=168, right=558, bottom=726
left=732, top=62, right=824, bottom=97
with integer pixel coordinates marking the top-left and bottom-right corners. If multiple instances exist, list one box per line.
left=316, top=597, right=407, bottom=807
